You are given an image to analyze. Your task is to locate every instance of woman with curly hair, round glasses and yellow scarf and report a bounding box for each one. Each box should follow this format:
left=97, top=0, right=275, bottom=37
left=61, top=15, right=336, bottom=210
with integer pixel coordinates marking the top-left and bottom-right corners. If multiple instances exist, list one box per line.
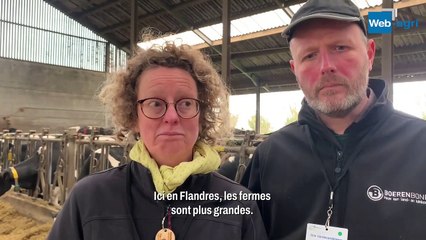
left=48, top=37, right=267, bottom=240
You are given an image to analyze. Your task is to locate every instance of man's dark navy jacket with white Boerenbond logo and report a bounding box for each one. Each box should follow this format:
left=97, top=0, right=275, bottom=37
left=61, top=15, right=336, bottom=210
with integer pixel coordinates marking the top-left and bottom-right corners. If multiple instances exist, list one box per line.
left=242, top=80, right=426, bottom=240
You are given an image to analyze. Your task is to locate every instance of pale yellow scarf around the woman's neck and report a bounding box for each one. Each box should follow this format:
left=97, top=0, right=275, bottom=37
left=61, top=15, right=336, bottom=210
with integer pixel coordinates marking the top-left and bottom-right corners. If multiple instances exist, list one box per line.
left=129, top=140, right=220, bottom=194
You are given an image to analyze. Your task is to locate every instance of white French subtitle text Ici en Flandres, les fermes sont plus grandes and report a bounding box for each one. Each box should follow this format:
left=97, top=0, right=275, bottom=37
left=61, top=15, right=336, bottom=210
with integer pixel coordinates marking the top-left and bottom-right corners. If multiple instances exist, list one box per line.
left=154, top=191, right=271, bottom=217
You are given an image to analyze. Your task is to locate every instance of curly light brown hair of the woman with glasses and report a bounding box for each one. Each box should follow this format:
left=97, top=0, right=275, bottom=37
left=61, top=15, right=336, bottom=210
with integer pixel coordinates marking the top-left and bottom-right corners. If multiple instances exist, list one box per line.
left=98, top=42, right=230, bottom=145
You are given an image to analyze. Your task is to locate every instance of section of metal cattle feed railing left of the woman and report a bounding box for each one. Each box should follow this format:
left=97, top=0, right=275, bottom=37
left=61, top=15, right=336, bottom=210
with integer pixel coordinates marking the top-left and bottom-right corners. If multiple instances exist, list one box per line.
left=0, top=129, right=128, bottom=205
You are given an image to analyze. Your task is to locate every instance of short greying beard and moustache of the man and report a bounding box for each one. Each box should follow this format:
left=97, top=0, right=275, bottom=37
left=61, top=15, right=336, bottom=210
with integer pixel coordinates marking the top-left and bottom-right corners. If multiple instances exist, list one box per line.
left=305, top=72, right=368, bottom=117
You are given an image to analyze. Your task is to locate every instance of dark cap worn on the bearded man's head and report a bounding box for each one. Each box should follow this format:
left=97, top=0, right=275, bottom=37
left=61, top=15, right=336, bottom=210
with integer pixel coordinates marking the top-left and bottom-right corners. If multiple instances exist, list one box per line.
left=281, top=0, right=367, bottom=42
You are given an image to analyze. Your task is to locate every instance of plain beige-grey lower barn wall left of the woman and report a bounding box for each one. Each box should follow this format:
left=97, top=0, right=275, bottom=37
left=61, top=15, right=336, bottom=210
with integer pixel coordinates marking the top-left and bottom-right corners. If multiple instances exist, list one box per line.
left=0, top=58, right=108, bottom=133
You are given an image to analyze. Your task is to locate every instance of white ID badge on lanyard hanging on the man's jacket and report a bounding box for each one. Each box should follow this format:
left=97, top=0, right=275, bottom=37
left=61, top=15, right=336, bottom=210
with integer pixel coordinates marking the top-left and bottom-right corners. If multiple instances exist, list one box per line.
left=305, top=191, right=348, bottom=240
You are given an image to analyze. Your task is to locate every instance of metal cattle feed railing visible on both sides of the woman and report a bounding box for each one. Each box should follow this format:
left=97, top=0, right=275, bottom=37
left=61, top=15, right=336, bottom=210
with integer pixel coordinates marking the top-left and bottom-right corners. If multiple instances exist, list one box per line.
left=0, top=128, right=267, bottom=205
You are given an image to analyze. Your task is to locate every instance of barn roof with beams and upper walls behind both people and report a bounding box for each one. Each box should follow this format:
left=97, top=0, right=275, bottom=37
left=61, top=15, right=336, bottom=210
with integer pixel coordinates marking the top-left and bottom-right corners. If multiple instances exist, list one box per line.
left=0, top=0, right=426, bottom=132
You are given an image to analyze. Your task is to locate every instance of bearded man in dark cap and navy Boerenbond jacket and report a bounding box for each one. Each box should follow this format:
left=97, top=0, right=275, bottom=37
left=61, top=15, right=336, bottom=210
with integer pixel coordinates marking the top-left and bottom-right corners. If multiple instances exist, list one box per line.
left=242, top=0, right=426, bottom=240
